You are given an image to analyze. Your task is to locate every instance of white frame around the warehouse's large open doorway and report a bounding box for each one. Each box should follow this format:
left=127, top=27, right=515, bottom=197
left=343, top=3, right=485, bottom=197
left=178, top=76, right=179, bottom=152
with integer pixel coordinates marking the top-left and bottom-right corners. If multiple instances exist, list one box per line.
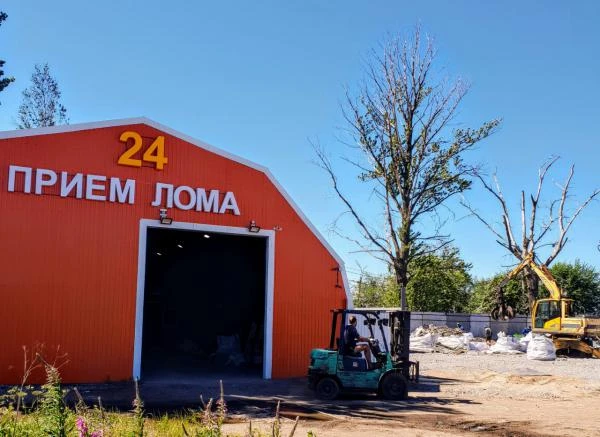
left=133, top=219, right=275, bottom=379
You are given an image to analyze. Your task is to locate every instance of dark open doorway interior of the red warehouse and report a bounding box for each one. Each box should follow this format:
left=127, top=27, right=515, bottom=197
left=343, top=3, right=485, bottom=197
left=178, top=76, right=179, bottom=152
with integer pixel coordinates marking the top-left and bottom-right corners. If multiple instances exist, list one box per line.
left=142, top=228, right=267, bottom=378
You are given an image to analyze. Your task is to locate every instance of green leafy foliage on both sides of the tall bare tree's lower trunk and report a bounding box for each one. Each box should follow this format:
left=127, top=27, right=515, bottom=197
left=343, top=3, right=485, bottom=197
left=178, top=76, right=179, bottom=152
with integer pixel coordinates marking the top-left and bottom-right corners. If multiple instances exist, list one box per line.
left=354, top=247, right=472, bottom=312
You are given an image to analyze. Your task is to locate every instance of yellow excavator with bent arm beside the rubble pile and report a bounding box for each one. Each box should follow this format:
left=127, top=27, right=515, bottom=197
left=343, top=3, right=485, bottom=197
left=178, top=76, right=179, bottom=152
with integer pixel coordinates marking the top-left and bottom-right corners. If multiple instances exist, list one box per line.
left=491, top=254, right=600, bottom=358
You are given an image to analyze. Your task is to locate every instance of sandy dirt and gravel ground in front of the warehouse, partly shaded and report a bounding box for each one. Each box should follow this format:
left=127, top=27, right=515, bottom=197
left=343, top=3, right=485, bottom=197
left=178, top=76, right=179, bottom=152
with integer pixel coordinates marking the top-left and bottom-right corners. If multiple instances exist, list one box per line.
left=68, top=353, right=600, bottom=437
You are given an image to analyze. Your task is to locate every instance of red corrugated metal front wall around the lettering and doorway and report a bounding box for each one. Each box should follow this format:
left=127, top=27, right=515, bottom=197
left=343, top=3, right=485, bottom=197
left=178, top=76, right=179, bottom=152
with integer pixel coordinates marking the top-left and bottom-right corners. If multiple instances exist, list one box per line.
left=0, top=123, right=346, bottom=384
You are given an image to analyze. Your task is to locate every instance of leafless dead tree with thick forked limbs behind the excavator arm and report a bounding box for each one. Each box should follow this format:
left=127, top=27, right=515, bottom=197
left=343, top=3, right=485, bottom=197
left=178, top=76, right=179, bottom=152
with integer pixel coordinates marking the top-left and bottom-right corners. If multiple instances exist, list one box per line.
left=462, top=157, right=600, bottom=311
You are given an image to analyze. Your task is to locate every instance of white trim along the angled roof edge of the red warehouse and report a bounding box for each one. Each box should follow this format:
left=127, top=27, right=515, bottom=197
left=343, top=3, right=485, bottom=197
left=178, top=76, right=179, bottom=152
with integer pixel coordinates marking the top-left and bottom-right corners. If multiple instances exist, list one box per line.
left=0, top=117, right=353, bottom=308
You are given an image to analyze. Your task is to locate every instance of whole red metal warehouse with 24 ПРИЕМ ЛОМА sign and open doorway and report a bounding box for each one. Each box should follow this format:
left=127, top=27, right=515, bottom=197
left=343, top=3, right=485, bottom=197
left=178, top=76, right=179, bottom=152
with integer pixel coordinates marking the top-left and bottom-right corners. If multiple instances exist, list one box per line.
left=0, top=118, right=351, bottom=384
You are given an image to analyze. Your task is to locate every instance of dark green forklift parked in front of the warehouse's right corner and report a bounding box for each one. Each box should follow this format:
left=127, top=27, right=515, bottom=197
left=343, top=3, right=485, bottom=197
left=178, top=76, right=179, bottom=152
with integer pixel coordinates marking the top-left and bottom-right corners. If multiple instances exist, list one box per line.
left=308, top=309, right=419, bottom=400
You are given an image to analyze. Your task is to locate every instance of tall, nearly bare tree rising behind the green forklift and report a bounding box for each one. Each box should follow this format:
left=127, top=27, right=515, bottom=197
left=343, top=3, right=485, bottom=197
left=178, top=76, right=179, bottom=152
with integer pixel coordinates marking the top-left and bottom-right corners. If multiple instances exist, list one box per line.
left=315, top=28, right=499, bottom=309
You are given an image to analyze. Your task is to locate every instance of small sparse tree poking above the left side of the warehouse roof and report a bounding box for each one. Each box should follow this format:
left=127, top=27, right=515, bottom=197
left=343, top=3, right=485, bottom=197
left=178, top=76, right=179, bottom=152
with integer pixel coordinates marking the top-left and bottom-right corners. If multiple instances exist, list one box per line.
left=17, top=64, right=69, bottom=129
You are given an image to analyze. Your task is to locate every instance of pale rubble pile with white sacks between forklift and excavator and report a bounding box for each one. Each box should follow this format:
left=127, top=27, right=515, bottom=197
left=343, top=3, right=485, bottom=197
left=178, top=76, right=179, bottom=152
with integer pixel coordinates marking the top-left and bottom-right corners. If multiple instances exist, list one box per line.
left=410, top=325, right=556, bottom=360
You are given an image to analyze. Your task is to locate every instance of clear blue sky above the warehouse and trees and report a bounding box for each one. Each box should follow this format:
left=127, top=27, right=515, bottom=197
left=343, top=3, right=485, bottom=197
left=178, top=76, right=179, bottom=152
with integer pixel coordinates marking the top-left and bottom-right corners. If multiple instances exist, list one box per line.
left=0, top=0, right=600, bottom=282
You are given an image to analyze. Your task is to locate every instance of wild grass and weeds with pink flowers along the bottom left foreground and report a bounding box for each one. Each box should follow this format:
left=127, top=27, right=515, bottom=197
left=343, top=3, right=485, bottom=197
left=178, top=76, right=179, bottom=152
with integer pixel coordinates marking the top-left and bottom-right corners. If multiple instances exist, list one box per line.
left=0, top=349, right=315, bottom=437
